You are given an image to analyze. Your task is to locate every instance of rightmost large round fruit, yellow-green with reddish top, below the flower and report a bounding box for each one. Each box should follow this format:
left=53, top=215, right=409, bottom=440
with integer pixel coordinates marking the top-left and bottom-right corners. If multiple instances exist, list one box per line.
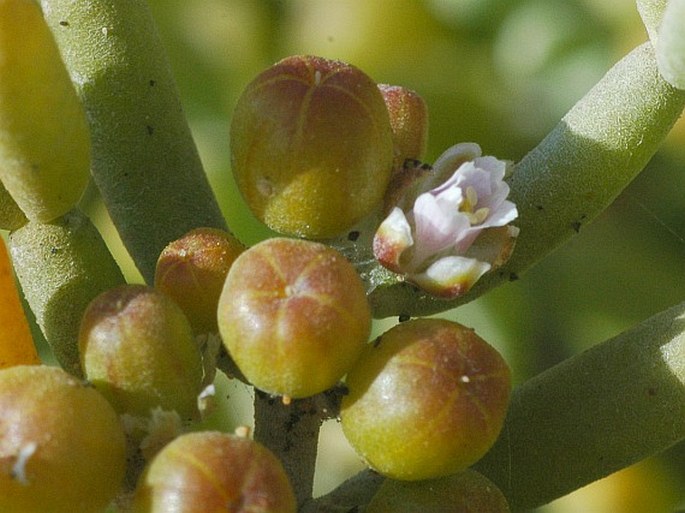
left=341, top=319, right=511, bottom=480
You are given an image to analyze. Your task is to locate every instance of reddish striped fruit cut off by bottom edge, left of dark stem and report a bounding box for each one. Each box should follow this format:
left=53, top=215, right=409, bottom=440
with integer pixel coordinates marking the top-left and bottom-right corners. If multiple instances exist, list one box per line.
left=133, top=432, right=296, bottom=513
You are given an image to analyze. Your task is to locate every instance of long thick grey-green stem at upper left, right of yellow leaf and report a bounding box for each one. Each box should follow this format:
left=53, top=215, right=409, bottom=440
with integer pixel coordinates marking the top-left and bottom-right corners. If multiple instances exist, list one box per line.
left=41, top=0, right=226, bottom=284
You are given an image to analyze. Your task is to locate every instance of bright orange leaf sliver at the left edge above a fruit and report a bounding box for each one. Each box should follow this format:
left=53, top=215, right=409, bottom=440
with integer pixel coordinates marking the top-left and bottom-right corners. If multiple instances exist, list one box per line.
left=0, top=240, right=40, bottom=369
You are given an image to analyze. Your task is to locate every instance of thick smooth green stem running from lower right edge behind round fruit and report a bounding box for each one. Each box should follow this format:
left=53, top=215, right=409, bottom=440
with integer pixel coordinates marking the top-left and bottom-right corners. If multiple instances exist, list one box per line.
left=476, top=303, right=685, bottom=511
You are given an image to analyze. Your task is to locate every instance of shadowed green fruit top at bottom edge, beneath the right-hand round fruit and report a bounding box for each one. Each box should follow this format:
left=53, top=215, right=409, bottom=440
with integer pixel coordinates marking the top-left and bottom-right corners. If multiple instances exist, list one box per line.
left=364, top=470, right=509, bottom=513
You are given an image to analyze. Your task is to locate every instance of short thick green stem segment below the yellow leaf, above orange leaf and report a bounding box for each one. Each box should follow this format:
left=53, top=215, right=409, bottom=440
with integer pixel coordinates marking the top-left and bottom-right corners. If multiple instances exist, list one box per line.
left=9, top=209, right=124, bottom=376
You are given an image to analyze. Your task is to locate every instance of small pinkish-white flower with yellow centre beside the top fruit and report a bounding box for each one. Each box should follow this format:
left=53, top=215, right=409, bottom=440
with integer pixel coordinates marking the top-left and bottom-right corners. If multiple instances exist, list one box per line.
left=373, top=143, right=518, bottom=298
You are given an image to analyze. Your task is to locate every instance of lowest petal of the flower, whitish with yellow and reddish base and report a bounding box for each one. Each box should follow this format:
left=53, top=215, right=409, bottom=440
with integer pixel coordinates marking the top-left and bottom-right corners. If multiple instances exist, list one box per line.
left=407, top=256, right=490, bottom=299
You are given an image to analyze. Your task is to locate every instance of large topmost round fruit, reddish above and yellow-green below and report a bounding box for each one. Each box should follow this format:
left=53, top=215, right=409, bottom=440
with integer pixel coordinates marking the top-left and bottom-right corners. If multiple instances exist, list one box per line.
left=231, top=56, right=393, bottom=239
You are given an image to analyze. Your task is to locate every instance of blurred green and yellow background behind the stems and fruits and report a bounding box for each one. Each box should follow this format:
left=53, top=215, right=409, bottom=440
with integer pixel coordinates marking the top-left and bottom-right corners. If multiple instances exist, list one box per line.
left=79, top=0, right=685, bottom=513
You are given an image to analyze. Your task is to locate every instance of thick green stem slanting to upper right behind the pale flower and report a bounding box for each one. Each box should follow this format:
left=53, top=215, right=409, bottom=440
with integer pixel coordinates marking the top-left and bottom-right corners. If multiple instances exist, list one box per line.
left=369, top=43, right=685, bottom=317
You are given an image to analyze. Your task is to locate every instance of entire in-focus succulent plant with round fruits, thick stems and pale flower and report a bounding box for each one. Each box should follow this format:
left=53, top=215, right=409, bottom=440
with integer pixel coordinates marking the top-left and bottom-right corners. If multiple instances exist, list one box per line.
left=0, top=0, right=685, bottom=513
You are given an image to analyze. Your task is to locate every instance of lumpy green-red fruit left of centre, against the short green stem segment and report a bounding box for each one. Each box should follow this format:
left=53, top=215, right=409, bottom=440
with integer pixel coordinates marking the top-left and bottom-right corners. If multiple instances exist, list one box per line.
left=79, top=285, right=202, bottom=418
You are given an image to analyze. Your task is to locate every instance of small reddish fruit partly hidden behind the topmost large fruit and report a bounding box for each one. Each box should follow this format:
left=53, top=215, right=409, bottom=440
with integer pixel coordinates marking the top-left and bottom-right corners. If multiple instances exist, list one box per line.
left=378, top=84, right=428, bottom=169
